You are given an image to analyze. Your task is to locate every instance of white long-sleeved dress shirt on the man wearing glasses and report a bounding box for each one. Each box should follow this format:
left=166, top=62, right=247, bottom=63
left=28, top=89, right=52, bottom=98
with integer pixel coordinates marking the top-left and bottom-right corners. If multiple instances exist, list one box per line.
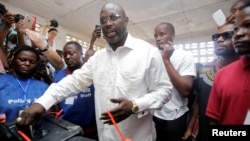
left=36, top=34, right=172, bottom=141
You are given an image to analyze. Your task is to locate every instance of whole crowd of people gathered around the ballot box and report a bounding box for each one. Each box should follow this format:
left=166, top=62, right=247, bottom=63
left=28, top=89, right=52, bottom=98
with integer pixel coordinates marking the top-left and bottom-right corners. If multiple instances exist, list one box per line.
left=0, top=0, right=250, bottom=141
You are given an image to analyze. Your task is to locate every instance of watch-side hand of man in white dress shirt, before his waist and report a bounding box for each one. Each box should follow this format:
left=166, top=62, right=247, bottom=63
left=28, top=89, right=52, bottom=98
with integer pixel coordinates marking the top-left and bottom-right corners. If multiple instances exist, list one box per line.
left=100, top=98, right=133, bottom=124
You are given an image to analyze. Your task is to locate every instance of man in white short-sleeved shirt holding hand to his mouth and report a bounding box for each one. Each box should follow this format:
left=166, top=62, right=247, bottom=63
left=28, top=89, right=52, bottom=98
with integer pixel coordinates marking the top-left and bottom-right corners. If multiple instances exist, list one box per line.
left=154, top=22, right=196, bottom=141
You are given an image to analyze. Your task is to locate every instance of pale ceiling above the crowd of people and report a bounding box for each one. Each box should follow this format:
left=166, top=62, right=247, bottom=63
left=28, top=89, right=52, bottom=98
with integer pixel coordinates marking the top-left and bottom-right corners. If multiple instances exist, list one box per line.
left=0, top=0, right=235, bottom=44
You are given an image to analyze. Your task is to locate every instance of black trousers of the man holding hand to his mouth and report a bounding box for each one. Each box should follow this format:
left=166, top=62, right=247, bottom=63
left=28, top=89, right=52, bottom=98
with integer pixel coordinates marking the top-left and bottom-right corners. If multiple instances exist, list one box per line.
left=153, top=112, right=187, bottom=141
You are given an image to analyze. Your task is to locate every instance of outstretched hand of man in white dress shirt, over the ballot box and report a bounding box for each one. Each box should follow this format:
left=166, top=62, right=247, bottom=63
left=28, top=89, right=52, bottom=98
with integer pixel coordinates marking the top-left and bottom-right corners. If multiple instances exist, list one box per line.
left=16, top=103, right=45, bottom=125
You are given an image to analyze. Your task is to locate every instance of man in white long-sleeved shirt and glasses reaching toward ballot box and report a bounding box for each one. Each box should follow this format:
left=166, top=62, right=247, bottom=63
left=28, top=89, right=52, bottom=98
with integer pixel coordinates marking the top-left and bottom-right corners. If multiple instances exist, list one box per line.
left=17, top=3, right=172, bottom=141
